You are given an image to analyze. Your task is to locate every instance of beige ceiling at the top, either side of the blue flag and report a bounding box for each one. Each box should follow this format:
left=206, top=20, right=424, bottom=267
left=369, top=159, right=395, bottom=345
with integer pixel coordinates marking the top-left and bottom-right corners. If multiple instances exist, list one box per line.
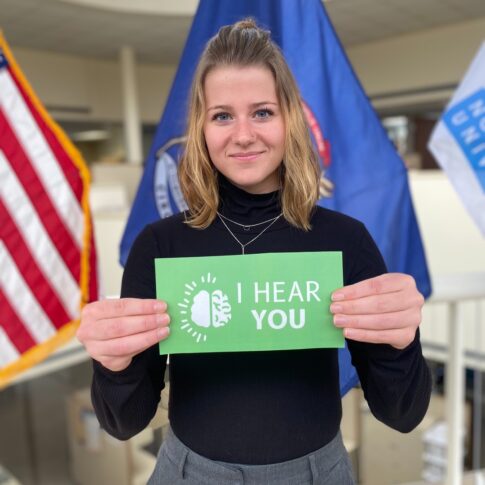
left=0, top=0, right=485, bottom=64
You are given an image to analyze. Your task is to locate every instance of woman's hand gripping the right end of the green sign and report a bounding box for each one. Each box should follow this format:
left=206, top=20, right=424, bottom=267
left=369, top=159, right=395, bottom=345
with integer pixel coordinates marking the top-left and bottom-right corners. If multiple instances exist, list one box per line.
left=330, top=273, right=424, bottom=349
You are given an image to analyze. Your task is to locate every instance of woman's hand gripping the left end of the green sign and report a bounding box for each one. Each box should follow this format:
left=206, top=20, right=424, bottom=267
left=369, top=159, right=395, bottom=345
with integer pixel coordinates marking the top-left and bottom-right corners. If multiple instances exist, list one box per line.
left=76, top=298, right=170, bottom=371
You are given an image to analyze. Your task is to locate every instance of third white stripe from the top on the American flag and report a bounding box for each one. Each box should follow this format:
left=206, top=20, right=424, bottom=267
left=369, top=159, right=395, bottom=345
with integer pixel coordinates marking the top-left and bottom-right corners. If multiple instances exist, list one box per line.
left=0, top=241, right=57, bottom=342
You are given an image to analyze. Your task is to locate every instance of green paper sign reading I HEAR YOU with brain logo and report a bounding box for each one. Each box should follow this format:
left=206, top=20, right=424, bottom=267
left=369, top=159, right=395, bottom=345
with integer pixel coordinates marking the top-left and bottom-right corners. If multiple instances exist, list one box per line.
left=155, top=252, right=344, bottom=354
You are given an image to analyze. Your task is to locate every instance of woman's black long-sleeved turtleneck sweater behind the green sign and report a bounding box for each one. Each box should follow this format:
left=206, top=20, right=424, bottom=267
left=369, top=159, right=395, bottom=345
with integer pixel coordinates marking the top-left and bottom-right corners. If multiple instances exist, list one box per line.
left=92, top=180, right=431, bottom=464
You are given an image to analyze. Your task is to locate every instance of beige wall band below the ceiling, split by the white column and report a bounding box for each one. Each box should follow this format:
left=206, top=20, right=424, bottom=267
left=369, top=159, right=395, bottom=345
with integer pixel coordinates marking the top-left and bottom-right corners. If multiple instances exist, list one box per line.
left=12, top=46, right=176, bottom=123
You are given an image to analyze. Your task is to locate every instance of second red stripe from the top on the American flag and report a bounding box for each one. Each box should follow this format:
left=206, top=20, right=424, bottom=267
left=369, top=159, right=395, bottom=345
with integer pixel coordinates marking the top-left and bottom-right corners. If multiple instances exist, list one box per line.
left=0, top=109, right=81, bottom=281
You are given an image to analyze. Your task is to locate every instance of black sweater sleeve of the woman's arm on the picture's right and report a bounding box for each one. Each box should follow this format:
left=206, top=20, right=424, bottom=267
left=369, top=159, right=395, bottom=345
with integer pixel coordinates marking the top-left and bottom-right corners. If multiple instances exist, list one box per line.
left=347, top=226, right=431, bottom=433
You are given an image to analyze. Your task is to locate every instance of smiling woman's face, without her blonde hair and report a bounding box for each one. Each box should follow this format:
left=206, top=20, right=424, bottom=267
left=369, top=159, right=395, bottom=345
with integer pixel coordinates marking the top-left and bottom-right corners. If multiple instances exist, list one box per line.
left=204, top=66, right=285, bottom=194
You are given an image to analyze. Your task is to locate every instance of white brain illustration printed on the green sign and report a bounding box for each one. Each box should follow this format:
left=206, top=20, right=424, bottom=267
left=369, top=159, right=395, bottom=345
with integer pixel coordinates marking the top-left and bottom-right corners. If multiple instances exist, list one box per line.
left=190, top=290, right=231, bottom=328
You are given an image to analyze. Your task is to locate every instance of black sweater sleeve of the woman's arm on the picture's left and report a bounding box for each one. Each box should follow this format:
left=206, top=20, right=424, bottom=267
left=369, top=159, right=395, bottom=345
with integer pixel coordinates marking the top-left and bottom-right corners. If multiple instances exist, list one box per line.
left=91, top=226, right=167, bottom=440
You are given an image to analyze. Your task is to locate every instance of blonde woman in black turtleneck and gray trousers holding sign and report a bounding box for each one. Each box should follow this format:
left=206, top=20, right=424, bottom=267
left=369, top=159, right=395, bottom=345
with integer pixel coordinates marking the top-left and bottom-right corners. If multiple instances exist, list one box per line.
left=78, top=20, right=431, bottom=485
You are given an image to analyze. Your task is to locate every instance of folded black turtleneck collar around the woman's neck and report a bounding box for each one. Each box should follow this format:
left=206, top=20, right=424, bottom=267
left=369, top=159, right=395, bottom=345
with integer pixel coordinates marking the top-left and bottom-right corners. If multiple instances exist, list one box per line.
left=219, top=174, right=281, bottom=229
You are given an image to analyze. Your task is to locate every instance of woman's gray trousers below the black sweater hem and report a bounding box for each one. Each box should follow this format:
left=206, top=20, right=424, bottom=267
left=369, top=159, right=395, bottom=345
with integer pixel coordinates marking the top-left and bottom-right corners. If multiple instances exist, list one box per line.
left=148, top=430, right=355, bottom=485
